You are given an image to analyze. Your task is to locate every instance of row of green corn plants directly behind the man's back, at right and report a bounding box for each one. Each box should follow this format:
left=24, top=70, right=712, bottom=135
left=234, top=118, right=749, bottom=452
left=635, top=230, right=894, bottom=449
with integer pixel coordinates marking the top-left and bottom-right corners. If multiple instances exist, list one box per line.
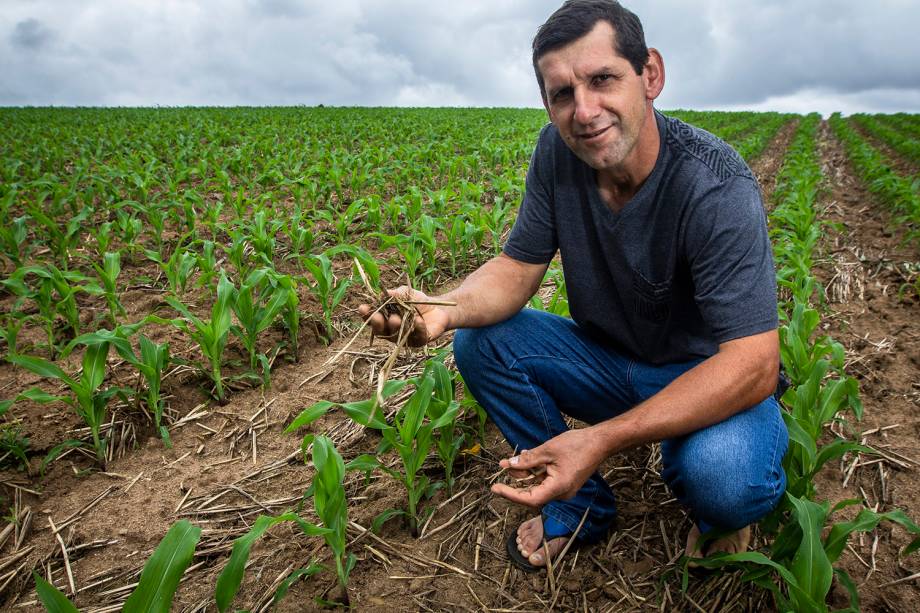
left=685, top=115, right=920, bottom=612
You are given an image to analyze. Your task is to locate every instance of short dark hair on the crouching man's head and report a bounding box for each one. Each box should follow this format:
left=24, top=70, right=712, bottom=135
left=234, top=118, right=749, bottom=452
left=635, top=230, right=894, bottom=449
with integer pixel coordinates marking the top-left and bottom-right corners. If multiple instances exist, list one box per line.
left=533, top=0, right=648, bottom=98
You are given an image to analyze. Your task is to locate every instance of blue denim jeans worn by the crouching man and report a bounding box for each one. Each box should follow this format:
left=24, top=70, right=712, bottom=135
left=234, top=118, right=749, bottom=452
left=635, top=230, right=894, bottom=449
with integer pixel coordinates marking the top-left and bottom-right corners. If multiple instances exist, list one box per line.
left=454, top=309, right=788, bottom=543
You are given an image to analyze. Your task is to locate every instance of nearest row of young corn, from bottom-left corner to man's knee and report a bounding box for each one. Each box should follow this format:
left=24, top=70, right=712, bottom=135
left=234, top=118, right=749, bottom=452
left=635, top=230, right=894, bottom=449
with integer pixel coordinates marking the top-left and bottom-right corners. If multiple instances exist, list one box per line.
left=28, top=355, right=481, bottom=612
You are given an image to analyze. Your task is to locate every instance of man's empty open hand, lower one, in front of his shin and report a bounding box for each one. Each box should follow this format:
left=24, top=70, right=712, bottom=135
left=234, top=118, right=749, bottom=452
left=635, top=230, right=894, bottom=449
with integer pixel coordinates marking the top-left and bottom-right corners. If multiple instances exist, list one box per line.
left=492, top=428, right=606, bottom=508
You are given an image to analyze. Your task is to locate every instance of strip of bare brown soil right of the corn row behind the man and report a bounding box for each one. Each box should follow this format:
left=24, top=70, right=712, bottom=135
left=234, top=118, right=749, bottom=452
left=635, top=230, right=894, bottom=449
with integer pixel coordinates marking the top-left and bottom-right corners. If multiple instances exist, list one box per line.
left=817, top=119, right=920, bottom=611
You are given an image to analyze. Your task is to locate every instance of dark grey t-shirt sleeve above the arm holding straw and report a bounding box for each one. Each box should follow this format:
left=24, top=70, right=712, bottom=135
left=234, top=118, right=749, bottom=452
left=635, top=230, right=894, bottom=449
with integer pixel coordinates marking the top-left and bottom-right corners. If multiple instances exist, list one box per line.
left=504, top=126, right=558, bottom=264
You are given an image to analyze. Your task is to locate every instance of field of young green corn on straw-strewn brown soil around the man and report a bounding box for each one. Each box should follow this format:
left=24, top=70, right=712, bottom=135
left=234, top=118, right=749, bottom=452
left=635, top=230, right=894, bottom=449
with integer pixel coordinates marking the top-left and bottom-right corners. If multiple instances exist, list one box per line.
left=0, top=108, right=920, bottom=613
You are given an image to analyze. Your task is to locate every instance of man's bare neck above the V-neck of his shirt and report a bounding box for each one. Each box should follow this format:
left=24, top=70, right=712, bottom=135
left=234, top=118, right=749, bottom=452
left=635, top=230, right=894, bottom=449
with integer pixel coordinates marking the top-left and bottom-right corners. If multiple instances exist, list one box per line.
left=595, top=107, right=661, bottom=213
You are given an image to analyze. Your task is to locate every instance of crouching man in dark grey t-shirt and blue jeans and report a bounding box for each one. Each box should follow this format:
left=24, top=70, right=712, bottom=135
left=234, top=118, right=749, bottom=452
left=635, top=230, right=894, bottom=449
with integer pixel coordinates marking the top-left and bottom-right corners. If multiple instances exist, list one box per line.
left=362, top=0, right=788, bottom=568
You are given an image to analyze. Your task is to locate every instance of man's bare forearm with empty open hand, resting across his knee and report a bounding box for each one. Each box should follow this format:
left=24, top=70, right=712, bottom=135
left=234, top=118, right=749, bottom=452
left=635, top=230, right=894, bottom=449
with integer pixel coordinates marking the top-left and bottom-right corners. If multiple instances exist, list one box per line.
left=492, top=330, right=779, bottom=507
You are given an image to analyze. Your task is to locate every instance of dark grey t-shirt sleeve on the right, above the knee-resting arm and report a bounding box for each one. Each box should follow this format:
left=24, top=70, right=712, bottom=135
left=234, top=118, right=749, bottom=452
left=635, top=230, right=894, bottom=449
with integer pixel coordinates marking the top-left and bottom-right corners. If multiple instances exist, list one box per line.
left=684, top=176, right=779, bottom=343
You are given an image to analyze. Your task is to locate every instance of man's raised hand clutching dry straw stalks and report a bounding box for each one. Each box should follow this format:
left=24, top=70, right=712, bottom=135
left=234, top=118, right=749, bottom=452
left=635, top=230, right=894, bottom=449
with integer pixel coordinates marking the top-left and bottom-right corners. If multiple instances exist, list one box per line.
left=358, top=285, right=454, bottom=347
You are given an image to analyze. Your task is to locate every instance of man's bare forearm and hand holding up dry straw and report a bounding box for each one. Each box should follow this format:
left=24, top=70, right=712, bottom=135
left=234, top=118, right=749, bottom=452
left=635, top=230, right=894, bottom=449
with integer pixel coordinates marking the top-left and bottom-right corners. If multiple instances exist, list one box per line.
left=359, top=253, right=548, bottom=344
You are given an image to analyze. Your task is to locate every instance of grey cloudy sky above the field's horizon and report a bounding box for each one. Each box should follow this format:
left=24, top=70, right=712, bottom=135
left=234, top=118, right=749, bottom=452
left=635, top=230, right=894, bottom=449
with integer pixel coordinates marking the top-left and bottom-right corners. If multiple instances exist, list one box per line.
left=0, top=0, right=920, bottom=113
